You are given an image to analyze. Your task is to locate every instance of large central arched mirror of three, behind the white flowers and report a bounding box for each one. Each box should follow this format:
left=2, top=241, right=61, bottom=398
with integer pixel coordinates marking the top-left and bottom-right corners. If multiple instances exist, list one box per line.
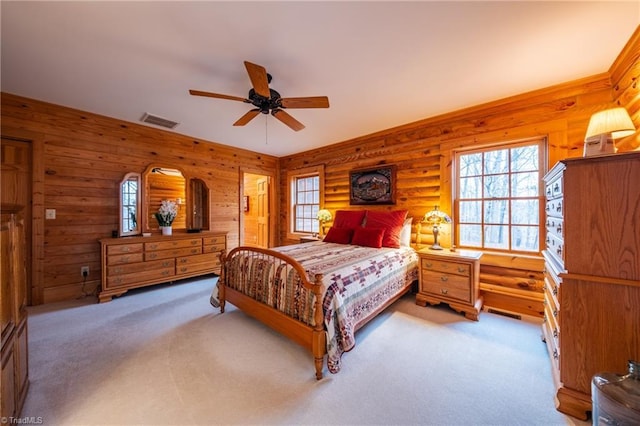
left=142, top=166, right=189, bottom=231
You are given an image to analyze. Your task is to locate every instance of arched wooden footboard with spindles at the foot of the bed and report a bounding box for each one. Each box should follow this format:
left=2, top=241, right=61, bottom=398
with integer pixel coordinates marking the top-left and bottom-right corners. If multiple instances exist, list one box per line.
left=218, top=246, right=327, bottom=380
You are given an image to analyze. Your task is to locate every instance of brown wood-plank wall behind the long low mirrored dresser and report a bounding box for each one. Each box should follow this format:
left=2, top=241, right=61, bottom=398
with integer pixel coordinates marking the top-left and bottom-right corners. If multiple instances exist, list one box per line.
left=2, top=93, right=278, bottom=304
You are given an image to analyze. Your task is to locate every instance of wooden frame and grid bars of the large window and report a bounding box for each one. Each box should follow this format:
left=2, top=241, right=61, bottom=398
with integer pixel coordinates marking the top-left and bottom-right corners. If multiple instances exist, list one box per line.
left=451, top=136, right=548, bottom=256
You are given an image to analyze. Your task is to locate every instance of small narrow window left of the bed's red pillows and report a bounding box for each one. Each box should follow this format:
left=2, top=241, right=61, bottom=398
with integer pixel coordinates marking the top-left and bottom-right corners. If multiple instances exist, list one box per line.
left=288, top=167, right=324, bottom=238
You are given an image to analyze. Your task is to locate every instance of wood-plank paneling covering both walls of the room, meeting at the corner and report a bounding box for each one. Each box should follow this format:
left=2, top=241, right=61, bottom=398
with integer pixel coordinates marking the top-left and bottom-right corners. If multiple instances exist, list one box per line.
left=1, top=25, right=640, bottom=314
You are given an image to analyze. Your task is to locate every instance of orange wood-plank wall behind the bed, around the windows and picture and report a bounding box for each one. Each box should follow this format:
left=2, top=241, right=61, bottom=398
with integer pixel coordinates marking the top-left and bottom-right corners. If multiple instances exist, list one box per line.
left=280, top=31, right=640, bottom=316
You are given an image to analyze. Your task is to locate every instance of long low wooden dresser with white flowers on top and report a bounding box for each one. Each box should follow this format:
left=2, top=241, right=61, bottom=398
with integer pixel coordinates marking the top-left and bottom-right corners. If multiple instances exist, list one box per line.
left=98, top=232, right=227, bottom=303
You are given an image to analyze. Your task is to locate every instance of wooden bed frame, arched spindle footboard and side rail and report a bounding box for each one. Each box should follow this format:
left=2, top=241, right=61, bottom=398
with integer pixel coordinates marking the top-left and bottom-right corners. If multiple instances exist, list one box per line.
left=218, top=246, right=411, bottom=380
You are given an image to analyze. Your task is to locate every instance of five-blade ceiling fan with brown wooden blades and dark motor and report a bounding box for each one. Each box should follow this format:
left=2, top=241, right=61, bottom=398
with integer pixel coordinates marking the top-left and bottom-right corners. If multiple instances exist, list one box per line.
left=189, top=61, right=329, bottom=132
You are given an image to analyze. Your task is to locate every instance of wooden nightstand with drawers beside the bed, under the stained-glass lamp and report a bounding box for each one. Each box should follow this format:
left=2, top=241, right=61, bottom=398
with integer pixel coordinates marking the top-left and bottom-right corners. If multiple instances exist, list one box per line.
left=416, top=249, right=482, bottom=321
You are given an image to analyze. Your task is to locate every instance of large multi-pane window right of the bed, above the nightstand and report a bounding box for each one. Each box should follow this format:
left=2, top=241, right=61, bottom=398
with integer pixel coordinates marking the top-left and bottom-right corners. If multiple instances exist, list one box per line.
left=455, top=140, right=545, bottom=253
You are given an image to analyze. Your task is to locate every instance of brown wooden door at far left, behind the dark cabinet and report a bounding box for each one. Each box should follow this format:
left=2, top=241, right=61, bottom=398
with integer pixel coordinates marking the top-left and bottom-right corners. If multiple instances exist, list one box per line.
left=0, top=137, right=32, bottom=305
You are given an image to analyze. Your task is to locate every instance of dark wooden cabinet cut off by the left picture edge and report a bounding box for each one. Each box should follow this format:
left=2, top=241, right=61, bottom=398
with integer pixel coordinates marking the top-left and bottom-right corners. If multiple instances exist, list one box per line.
left=0, top=204, right=29, bottom=423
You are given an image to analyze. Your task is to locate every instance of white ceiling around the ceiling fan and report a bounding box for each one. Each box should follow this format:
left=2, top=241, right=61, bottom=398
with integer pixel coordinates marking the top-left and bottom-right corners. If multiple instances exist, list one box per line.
left=0, top=0, right=640, bottom=156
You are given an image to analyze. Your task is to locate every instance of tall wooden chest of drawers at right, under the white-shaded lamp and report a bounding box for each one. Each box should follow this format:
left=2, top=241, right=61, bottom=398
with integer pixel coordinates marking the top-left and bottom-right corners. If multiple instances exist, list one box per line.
left=542, top=152, right=640, bottom=420
